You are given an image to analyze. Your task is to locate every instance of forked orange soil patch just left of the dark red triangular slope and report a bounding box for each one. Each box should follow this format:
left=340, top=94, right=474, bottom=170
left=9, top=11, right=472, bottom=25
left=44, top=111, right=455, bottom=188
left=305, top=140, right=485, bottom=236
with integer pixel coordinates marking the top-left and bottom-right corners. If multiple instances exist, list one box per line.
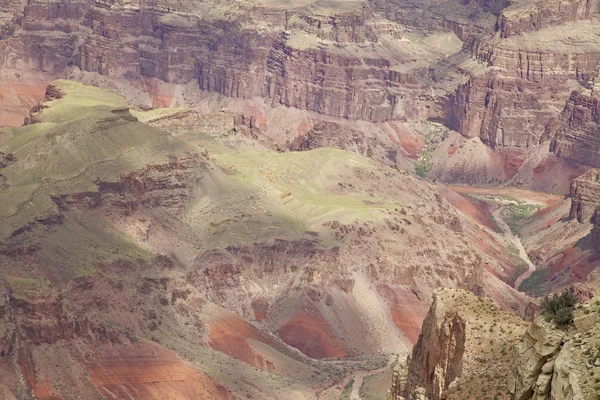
left=208, top=315, right=275, bottom=372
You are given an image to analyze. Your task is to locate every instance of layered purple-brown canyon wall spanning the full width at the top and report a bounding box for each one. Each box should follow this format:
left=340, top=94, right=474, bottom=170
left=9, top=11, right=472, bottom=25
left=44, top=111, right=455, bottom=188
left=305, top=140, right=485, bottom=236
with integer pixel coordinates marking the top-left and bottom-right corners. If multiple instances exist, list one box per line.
left=0, top=0, right=600, bottom=166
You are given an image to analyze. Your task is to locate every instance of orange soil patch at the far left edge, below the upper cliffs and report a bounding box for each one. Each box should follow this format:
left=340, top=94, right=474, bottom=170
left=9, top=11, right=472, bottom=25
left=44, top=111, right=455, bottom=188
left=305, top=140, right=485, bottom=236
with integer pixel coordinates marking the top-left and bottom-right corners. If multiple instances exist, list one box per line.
left=0, top=83, right=46, bottom=126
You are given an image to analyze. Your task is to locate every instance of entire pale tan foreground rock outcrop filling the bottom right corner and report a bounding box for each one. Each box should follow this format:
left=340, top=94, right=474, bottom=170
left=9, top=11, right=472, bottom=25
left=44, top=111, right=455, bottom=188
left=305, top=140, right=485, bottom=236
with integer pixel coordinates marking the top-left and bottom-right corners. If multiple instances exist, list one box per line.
left=396, top=291, right=600, bottom=400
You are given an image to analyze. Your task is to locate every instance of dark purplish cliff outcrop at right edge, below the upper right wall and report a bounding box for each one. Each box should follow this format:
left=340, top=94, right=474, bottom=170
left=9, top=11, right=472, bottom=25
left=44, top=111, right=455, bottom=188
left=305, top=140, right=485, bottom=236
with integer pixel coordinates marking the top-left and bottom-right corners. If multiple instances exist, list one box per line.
left=548, top=91, right=600, bottom=167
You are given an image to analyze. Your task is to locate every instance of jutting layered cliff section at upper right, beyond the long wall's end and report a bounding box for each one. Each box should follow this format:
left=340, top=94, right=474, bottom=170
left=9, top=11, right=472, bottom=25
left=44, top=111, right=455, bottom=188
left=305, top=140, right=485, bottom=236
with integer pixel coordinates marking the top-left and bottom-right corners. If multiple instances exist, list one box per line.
left=454, top=16, right=600, bottom=147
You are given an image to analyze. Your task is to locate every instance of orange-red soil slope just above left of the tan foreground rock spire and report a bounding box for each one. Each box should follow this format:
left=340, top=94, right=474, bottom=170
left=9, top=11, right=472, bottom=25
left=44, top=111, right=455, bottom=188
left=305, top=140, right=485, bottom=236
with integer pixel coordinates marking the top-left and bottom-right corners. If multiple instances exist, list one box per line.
left=377, top=285, right=428, bottom=345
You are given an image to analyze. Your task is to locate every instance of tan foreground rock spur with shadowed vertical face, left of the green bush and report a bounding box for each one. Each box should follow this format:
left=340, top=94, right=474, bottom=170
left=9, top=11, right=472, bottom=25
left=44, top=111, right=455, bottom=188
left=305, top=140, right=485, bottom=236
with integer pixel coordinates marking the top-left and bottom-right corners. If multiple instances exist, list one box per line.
left=400, top=289, right=526, bottom=399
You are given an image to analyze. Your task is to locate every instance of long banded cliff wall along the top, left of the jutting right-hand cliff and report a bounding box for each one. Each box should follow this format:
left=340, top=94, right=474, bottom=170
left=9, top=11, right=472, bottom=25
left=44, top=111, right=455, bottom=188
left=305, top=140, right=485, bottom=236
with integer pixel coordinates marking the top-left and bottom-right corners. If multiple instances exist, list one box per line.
left=0, top=0, right=468, bottom=126
